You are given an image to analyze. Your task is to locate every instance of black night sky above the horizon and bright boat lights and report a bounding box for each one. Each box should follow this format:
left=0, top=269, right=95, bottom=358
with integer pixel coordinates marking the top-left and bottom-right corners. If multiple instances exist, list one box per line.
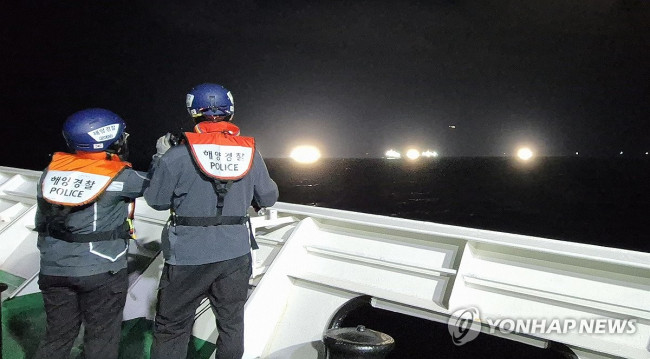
left=0, top=0, right=650, bottom=169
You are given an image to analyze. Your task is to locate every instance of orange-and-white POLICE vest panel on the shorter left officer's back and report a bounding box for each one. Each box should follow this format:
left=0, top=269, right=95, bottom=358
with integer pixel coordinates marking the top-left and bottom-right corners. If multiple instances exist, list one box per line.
left=41, top=152, right=131, bottom=207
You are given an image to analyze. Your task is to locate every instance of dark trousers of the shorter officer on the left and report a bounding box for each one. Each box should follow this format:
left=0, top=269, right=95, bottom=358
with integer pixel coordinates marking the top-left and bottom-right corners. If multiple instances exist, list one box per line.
left=36, top=269, right=129, bottom=359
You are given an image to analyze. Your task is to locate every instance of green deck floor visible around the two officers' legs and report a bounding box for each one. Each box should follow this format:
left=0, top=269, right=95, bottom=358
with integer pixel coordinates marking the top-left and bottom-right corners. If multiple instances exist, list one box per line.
left=2, top=293, right=215, bottom=359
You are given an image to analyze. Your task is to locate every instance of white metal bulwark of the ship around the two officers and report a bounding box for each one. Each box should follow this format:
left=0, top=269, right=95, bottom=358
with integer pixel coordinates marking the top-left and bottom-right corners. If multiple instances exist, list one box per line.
left=0, top=167, right=650, bottom=359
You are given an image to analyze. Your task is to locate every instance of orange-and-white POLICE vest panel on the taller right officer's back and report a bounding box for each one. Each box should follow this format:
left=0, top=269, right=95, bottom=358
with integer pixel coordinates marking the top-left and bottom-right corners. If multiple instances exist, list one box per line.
left=185, top=121, right=255, bottom=181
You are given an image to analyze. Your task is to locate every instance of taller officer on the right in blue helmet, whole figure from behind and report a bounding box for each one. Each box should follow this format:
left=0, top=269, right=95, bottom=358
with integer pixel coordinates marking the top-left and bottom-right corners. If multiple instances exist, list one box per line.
left=144, top=83, right=278, bottom=359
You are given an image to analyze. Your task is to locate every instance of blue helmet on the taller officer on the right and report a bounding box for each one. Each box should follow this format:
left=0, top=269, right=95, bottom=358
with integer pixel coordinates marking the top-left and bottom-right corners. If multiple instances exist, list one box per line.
left=185, top=83, right=235, bottom=121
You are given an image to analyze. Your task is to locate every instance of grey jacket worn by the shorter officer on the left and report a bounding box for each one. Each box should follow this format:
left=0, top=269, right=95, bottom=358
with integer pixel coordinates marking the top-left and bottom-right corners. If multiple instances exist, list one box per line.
left=35, top=152, right=148, bottom=277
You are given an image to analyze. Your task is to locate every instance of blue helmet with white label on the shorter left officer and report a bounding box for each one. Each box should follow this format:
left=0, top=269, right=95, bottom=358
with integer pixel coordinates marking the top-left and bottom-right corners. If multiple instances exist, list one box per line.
left=63, top=108, right=127, bottom=152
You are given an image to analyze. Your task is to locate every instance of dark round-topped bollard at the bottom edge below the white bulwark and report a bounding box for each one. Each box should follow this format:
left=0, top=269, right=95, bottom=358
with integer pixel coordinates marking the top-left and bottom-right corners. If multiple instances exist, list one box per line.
left=323, top=325, right=395, bottom=359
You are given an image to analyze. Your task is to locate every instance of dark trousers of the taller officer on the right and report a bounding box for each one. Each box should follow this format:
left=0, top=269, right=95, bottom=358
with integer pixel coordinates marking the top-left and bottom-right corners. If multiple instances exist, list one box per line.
left=151, top=253, right=252, bottom=359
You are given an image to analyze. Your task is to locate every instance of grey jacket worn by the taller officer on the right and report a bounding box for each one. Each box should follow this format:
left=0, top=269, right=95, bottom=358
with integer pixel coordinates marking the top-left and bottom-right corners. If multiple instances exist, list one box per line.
left=144, top=122, right=278, bottom=265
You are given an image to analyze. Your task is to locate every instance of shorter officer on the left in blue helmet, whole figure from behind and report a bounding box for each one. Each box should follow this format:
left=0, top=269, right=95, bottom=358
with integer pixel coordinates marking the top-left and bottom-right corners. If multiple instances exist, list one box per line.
left=35, top=108, right=148, bottom=358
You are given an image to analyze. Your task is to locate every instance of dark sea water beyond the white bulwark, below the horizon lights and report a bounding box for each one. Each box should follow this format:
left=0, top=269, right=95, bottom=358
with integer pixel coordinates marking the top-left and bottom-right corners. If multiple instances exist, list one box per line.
left=266, top=157, right=650, bottom=359
